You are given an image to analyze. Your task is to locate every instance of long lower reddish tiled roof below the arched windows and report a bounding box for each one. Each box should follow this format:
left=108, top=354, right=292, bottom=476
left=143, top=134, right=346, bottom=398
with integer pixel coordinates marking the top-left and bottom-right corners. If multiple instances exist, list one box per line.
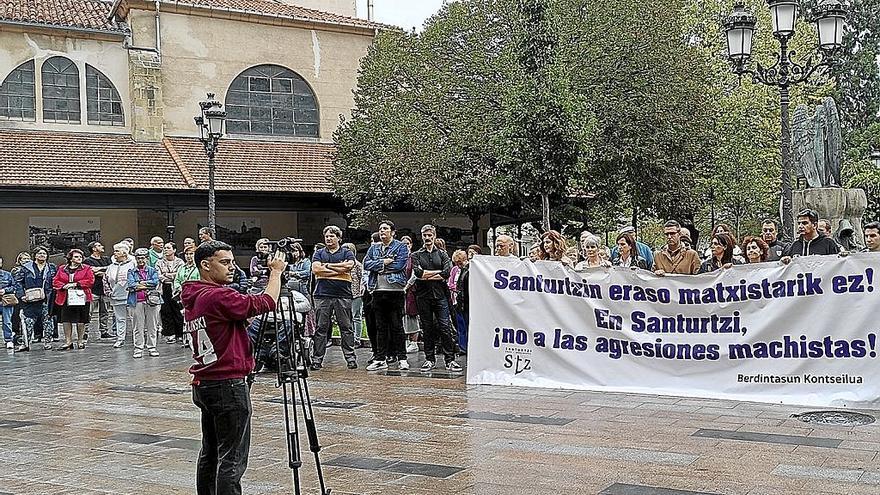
left=0, top=129, right=334, bottom=194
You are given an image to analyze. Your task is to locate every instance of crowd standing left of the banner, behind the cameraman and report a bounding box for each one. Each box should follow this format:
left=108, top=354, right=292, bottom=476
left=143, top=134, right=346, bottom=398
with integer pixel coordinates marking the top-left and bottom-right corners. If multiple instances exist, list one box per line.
left=0, top=220, right=482, bottom=372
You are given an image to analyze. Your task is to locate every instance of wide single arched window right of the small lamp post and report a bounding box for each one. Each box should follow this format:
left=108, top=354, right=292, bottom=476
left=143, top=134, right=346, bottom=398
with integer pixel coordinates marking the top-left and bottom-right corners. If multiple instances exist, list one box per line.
left=226, top=65, right=318, bottom=137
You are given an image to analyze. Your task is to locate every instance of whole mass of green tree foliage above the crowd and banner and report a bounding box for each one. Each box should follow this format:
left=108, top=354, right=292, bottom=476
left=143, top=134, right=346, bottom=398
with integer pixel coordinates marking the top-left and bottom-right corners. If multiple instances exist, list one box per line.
left=333, top=0, right=880, bottom=236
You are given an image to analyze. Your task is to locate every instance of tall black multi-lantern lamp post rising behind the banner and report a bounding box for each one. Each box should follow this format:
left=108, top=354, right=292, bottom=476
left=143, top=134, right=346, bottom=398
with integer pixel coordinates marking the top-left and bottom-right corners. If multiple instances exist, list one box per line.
left=724, top=0, right=846, bottom=239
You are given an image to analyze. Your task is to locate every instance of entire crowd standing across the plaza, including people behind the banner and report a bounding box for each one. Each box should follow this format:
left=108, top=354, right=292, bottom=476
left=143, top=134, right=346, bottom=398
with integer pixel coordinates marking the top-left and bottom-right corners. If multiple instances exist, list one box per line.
left=0, top=210, right=880, bottom=372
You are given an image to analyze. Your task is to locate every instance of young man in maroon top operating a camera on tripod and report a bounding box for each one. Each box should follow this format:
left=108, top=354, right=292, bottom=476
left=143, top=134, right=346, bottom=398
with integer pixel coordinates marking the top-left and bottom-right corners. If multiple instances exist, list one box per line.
left=181, top=241, right=287, bottom=495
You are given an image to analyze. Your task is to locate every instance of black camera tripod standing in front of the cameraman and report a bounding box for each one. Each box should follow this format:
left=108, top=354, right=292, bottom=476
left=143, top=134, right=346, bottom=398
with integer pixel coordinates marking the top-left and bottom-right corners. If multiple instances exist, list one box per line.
left=248, top=287, right=330, bottom=495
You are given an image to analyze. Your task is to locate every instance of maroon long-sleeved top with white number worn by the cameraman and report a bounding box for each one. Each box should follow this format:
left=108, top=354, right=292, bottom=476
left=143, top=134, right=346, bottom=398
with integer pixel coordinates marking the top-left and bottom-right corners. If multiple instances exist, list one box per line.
left=180, top=280, right=275, bottom=385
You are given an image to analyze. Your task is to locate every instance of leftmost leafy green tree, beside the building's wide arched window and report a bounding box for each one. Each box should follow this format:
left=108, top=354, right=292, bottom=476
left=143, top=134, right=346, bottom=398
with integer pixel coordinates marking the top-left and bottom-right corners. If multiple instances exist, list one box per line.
left=333, top=1, right=519, bottom=235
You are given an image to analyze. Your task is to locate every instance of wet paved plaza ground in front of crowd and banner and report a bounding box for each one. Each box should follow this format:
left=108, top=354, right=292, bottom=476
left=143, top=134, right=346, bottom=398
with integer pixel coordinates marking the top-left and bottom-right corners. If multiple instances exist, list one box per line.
left=0, top=343, right=880, bottom=495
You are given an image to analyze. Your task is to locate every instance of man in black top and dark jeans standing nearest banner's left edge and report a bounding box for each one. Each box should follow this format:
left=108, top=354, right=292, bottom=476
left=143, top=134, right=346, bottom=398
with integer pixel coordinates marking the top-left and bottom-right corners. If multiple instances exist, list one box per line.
left=412, top=225, right=461, bottom=372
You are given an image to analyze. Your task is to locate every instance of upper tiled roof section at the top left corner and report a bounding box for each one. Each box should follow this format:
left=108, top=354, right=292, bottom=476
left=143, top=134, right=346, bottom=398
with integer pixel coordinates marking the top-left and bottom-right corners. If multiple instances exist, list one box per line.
left=0, top=0, right=125, bottom=32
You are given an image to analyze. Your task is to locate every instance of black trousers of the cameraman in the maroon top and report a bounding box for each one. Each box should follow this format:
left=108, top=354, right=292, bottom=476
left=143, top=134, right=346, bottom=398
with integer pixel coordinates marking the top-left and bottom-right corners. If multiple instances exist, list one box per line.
left=193, top=378, right=251, bottom=495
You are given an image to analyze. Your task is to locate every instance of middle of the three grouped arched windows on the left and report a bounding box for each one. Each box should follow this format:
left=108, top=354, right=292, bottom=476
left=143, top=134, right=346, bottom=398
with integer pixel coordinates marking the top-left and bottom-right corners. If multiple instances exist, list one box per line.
left=40, top=57, right=80, bottom=124
